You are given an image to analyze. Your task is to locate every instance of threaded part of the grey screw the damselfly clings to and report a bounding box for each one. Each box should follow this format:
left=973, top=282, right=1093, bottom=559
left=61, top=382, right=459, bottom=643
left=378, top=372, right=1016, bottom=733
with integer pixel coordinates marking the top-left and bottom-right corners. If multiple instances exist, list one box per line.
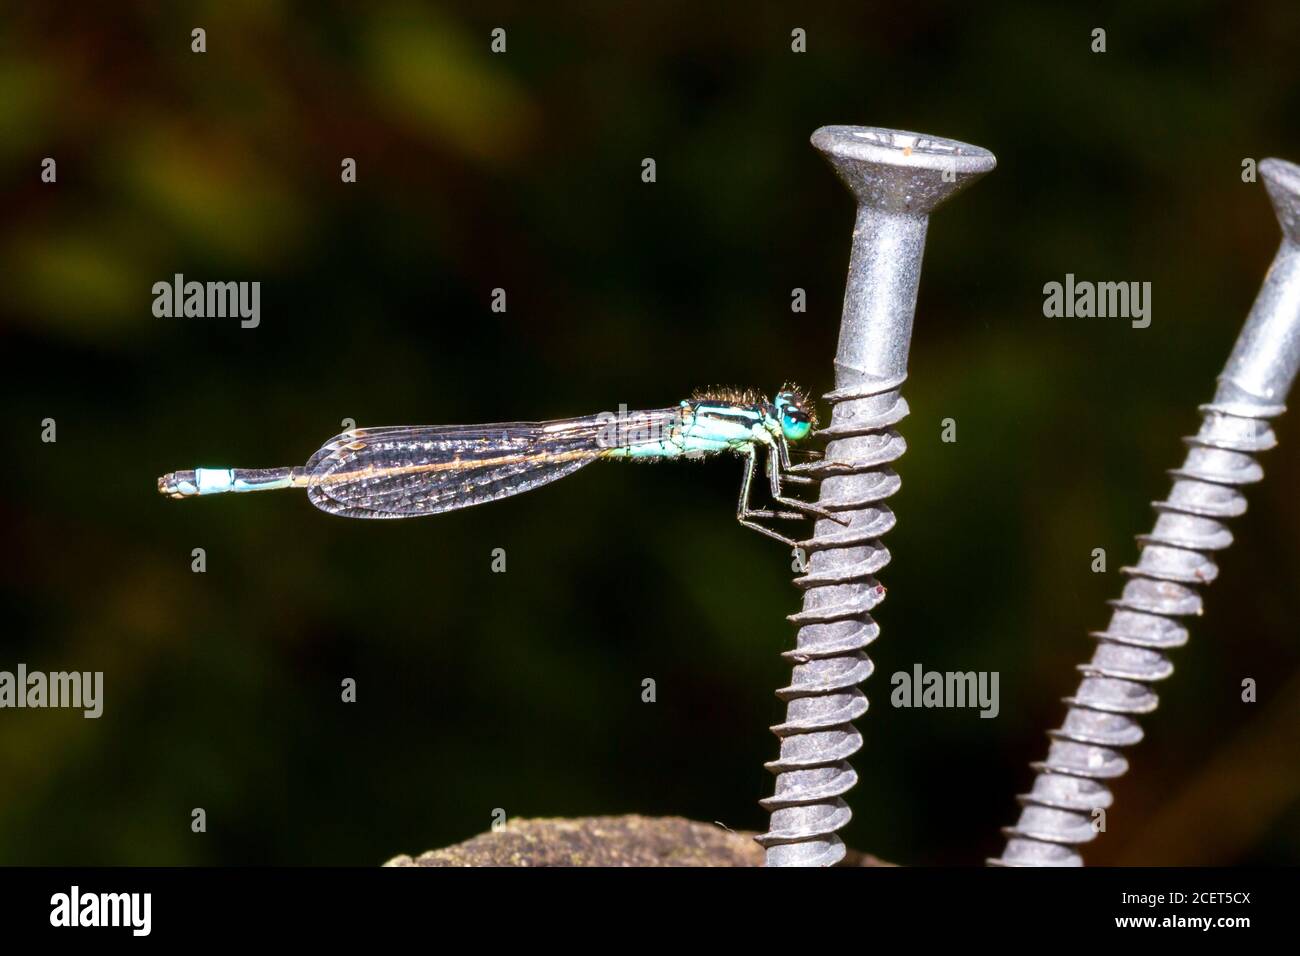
left=757, top=377, right=907, bottom=866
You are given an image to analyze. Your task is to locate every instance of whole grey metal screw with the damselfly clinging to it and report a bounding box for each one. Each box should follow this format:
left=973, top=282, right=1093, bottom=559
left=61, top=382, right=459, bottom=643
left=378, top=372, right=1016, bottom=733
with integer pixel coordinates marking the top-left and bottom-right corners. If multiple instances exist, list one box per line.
left=757, top=126, right=997, bottom=866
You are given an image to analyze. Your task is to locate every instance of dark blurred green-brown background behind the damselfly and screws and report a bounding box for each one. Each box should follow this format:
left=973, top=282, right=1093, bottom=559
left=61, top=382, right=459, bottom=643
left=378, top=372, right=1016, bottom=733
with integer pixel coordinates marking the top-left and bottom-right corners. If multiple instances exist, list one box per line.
left=0, top=3, right=1300, bottom=865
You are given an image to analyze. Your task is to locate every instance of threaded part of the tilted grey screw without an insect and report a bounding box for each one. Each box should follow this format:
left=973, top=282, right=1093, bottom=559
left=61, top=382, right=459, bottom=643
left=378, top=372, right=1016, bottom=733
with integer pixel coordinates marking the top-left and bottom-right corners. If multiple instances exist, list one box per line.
left=988, top=401, right=1284, bottom=866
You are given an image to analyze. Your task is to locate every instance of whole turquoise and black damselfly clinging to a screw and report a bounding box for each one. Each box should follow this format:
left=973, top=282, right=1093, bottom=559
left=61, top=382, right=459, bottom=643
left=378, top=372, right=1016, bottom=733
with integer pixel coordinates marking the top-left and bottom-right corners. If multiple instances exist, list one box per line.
left=159, top=388, right=842, bottom=546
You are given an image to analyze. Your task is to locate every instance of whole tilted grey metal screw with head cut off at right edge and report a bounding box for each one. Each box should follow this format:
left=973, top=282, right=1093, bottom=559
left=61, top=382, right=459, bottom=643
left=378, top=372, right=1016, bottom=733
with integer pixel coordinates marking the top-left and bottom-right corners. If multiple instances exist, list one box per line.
left=988, top=159, right=1300, bottom=866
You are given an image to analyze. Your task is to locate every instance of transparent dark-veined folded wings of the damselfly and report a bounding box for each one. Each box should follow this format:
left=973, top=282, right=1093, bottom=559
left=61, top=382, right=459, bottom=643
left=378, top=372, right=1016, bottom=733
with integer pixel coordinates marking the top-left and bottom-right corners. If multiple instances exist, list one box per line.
left=306, top=407, right=681, bottom=518
